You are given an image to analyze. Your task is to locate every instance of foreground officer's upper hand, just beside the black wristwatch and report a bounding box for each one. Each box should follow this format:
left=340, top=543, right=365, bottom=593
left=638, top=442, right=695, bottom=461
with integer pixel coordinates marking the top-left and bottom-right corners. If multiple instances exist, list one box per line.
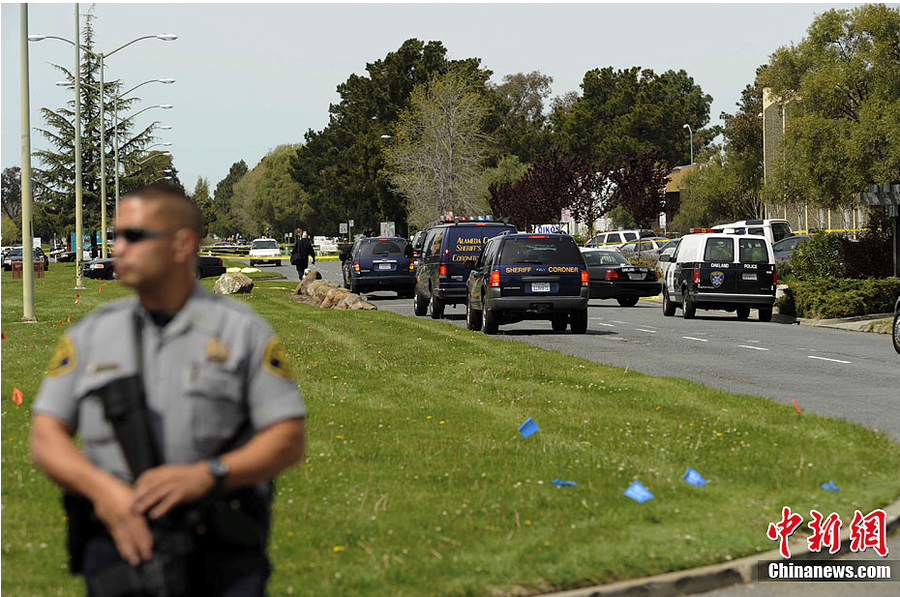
left=132, top=461, right=216, bottom=519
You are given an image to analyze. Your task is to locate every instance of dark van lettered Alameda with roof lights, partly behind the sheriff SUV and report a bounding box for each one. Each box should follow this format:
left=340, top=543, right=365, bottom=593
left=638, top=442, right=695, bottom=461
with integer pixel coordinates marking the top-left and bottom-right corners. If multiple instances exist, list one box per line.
left=413, top=220, right=516, bottom=319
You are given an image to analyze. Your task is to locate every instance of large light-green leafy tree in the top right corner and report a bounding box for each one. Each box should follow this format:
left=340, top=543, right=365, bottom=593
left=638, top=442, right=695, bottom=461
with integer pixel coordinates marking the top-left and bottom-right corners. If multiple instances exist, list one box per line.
left=761, top=4, right=900, bottom=208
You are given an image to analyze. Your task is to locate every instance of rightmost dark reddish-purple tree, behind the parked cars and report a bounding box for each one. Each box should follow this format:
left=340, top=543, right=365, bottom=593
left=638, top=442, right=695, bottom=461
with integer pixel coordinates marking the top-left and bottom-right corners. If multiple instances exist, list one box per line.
left=604, top=151, right=674, bottom=228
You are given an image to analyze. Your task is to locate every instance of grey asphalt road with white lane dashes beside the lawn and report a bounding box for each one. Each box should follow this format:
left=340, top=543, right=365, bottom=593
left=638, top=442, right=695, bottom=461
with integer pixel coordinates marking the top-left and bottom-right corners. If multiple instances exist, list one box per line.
left=267, top=262, right=900, bottom=597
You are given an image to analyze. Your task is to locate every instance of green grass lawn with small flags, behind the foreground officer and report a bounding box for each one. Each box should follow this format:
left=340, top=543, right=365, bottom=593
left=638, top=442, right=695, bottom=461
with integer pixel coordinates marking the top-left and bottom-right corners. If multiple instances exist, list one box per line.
left=2, top=264, right=900, bottom=596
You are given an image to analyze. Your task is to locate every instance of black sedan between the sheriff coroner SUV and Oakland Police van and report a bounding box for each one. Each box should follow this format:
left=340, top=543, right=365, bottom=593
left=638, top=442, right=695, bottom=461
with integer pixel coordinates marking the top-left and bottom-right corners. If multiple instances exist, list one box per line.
left=581, top=248, right=662, bottom=307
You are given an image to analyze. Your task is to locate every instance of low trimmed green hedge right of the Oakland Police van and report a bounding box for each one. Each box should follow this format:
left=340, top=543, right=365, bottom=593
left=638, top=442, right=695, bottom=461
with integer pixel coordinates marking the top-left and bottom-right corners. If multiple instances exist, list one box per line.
left=775, top=278, right=900, bottom=319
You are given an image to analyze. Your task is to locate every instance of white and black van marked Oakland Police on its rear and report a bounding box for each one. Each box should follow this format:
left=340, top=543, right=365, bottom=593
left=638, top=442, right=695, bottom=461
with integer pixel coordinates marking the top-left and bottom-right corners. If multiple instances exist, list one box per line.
left=659, top=232, right=778, bottom=321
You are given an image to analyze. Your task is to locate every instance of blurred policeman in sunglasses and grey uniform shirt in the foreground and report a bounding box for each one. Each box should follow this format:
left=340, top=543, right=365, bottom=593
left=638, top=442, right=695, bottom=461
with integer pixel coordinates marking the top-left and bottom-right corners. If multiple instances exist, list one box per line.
left=31, top=186, right=306, bottom=596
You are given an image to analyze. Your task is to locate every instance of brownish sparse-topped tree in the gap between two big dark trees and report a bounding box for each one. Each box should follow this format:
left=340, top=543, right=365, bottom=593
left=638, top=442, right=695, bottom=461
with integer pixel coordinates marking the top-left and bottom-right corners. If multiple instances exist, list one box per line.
left=492, top=71, right=553, bottom=163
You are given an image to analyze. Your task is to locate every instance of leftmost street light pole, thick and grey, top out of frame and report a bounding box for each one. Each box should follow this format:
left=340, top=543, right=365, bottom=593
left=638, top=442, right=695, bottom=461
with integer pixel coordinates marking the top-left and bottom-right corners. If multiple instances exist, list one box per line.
left=19, top=3, right=37, bottom=322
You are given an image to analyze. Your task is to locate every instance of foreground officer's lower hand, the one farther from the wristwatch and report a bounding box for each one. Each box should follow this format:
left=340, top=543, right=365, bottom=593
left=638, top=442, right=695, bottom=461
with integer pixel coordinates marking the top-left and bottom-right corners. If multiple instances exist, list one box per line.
left=94, top=480, right=153, bottom=566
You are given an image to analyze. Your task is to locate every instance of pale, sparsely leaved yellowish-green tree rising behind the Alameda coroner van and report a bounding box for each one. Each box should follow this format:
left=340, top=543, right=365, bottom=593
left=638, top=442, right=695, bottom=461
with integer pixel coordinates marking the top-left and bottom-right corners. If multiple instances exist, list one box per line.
left=384, top=71, right=487, bottom=228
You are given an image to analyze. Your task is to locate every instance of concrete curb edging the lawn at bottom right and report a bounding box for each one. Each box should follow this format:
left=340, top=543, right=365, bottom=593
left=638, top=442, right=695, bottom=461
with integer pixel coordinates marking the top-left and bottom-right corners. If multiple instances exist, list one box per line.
left=544, top=498, right=900, bottom=597
